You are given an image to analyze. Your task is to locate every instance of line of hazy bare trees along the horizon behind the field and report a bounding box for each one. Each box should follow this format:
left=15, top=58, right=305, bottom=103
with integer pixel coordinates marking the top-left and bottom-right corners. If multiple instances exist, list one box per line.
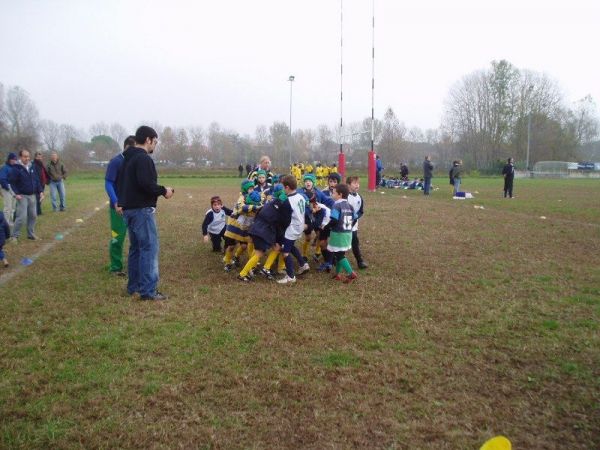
left=0, top=60, right=600, bottom=171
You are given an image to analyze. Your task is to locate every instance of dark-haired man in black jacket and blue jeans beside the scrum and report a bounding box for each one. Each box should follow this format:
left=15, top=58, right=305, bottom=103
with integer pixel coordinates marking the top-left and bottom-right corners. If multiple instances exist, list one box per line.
left=118, top=125, right=174, bottom=300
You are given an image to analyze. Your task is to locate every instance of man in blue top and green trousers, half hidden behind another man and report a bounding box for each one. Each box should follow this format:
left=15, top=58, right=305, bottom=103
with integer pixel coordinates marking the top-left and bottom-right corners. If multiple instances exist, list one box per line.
left=104, top=136, right=135, bottom=277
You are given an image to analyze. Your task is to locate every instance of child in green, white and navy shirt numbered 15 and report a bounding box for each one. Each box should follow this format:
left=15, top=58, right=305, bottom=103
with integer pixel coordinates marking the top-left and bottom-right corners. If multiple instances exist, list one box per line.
left=327, top=184, right=358, bottom=283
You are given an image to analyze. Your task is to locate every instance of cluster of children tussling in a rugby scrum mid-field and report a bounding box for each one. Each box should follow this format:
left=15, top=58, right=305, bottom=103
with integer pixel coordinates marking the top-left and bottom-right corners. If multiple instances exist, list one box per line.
left=202, top=165, right=367, bottom=284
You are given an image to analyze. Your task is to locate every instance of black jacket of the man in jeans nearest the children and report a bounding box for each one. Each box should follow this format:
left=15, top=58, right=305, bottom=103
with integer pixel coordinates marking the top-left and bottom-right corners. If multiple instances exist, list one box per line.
left=118, top=147, right=167, bottom=209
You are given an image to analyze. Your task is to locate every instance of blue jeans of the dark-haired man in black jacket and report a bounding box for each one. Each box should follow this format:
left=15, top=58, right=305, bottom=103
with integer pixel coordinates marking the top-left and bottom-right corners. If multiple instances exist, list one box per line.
left=123, top=207, right=159, bottom=298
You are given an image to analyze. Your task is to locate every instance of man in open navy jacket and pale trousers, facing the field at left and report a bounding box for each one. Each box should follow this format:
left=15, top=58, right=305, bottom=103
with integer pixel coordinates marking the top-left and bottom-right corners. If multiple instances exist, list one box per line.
left=10, top=150, right=44, bottom=242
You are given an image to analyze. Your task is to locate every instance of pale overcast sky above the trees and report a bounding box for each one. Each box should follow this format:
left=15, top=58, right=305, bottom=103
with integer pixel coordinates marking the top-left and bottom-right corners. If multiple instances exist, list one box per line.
left=0, top=0, right=600, bottom=134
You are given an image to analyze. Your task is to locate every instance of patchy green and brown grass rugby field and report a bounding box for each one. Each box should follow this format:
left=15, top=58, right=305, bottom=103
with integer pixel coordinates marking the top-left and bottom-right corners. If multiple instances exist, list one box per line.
left=0, top=177, right=600, bottom=449
